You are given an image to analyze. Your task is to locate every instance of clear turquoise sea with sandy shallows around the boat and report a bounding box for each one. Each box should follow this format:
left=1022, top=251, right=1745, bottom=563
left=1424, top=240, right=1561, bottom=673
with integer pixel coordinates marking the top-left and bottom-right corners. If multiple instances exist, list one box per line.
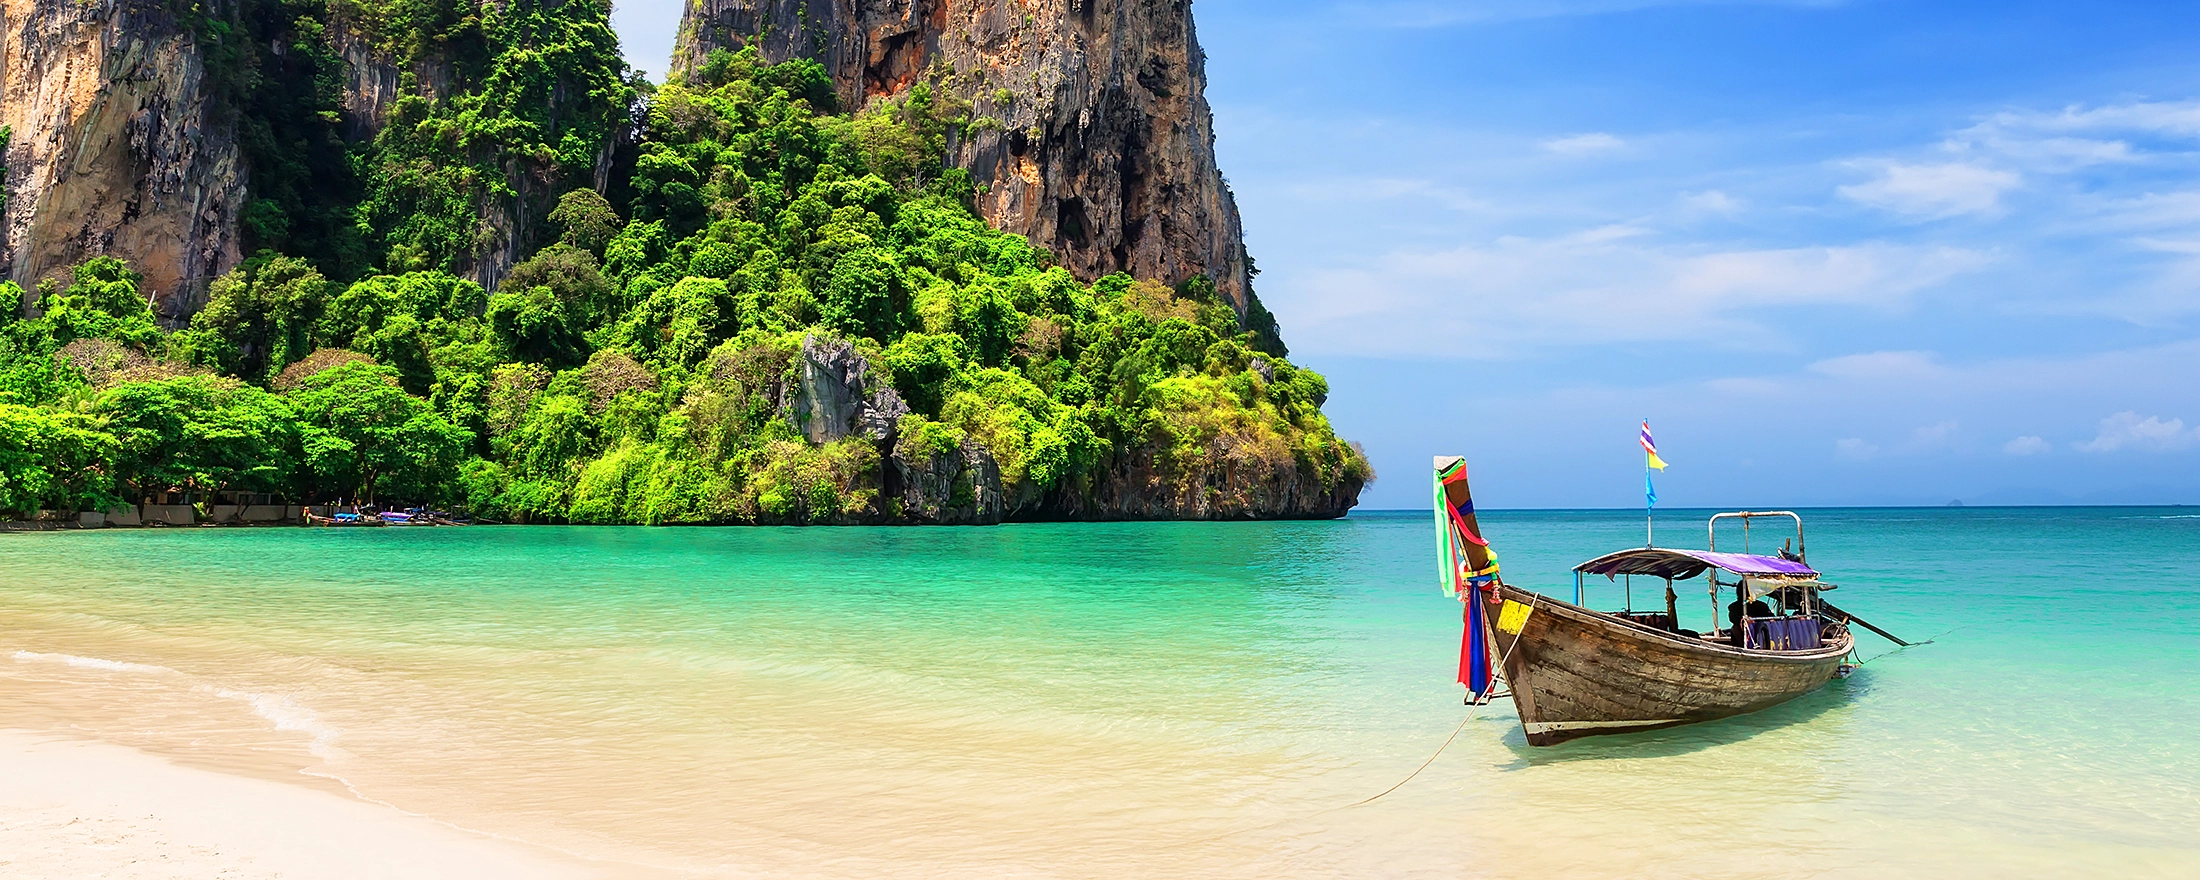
left=0, top=508, right=2200, bottom=878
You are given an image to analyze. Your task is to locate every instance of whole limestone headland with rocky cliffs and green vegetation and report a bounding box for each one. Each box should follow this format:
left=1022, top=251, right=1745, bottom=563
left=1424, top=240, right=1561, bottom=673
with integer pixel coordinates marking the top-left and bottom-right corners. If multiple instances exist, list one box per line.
left=0, top=2, right=1373, bottom=524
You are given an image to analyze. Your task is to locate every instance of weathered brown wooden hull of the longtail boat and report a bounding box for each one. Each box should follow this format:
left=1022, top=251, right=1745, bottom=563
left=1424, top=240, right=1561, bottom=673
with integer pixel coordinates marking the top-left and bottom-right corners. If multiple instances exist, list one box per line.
left=1485, top=585, right=1852, bottom=746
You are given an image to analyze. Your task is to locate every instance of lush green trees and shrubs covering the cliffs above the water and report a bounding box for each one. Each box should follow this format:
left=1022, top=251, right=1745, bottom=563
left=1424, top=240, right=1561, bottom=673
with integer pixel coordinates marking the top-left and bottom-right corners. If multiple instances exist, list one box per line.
left=0, top=0, right=1368, bottom=524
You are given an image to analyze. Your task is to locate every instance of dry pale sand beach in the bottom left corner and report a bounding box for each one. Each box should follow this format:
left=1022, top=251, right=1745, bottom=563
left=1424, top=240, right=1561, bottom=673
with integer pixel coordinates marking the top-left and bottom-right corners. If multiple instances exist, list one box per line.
left=0, top=730, right=605, bottom=880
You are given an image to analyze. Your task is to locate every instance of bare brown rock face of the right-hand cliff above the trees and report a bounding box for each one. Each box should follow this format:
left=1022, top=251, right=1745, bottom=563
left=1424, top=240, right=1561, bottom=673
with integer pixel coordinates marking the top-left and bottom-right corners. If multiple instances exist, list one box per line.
left=673, top=0, right=1250, bottom=315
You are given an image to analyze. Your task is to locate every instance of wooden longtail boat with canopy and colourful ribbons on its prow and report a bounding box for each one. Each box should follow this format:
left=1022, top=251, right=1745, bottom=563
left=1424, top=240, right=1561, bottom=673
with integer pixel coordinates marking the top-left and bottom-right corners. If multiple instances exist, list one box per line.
left=1437, top=458, right=1855, bottom=746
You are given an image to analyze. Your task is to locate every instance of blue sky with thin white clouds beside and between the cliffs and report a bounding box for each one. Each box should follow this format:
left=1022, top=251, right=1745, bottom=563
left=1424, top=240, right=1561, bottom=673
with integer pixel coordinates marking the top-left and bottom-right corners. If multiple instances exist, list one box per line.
left=616, top=0, right=2200, bottom=508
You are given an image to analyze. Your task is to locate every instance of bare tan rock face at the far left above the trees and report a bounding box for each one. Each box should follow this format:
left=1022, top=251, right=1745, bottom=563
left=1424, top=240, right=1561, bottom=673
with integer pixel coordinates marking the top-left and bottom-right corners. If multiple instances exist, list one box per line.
left=0, top=0, right=244, bottom=321
